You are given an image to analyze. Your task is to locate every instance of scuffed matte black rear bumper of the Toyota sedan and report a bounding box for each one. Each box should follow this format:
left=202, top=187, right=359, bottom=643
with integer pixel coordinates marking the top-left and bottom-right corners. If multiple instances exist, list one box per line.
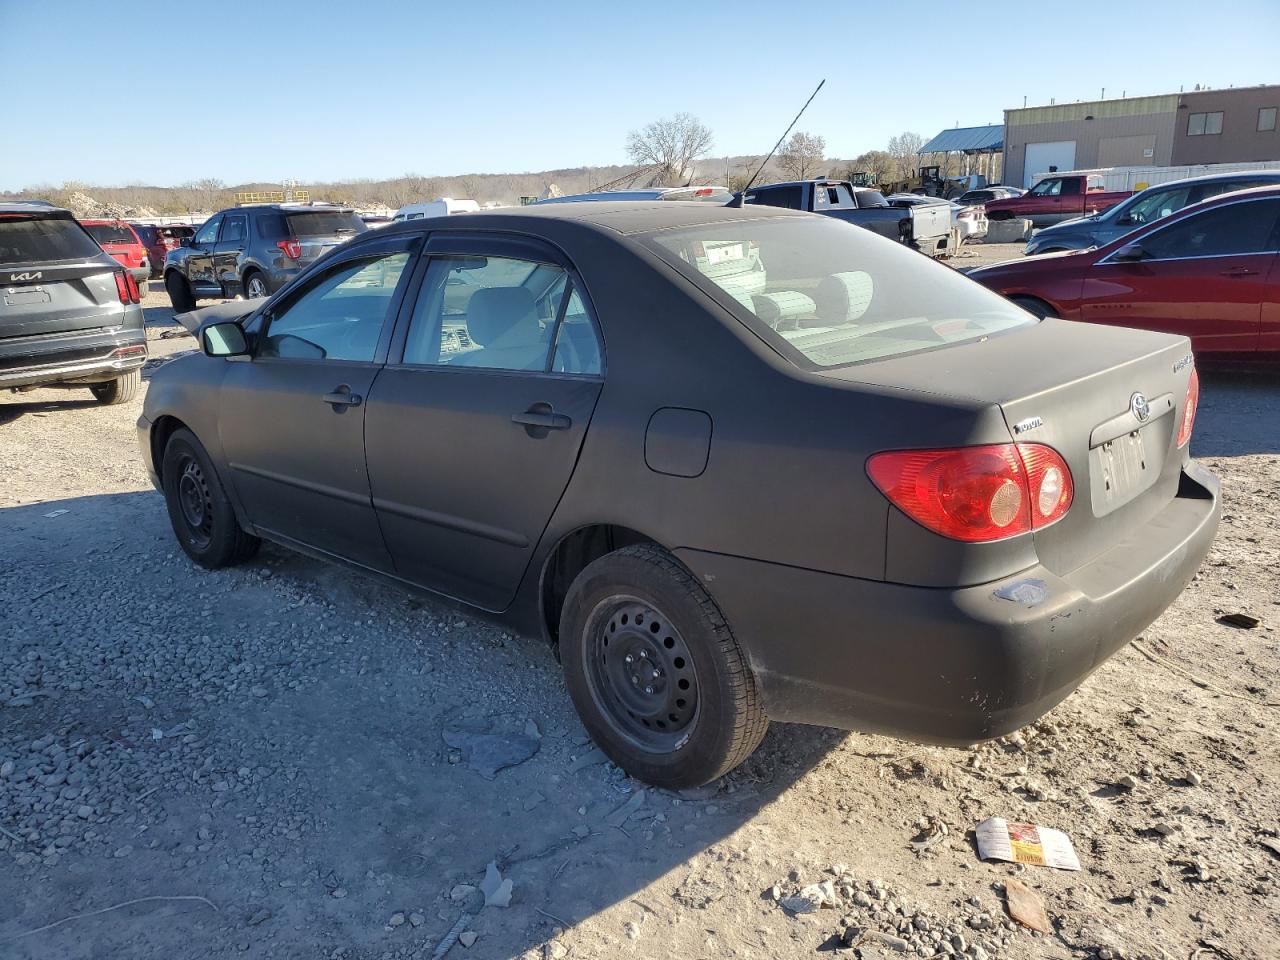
left=677, top=463, right=1221, bottom=745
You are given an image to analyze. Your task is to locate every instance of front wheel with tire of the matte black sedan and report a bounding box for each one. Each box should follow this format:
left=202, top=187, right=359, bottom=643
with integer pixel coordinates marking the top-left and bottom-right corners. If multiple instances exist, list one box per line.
left=161, top=429, right=261, bottom=570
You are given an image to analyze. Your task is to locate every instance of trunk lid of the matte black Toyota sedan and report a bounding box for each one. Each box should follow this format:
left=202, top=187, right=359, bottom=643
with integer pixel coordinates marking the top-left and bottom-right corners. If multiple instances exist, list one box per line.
left=823, top=320, right=1193, bottom=575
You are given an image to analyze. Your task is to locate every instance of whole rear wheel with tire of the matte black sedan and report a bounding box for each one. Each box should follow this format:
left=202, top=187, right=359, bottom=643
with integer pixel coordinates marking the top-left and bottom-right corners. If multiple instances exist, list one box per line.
left=559, top=544, right=769, bottom=788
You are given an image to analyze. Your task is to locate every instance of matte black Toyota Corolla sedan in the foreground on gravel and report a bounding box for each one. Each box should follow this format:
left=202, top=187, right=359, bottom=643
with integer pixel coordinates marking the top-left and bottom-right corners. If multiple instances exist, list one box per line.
left=138, top=202, right=1220, bottom=786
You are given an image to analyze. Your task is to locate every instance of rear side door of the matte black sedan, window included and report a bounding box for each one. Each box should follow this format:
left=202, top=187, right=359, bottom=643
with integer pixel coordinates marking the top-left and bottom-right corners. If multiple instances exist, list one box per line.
left=365, top=236, right=604, bottom=611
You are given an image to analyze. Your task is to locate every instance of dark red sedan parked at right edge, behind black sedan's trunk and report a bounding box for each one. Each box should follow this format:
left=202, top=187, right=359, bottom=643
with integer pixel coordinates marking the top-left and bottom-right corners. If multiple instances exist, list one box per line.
left=969, top=187, right=1280, bottom=361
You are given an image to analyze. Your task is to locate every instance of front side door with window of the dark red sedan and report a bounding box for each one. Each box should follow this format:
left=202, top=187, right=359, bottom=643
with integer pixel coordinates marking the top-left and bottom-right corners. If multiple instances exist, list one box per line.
left=1080, top=200, right=1280, bottom=356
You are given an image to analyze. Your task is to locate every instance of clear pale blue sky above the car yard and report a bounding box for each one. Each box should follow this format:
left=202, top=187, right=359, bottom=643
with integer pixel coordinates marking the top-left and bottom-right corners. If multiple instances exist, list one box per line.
left=0, top=0, right=1280, bottom=189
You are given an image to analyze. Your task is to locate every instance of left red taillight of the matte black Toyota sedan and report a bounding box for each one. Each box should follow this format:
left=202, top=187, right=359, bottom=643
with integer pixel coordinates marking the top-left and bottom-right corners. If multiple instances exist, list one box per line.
left=867, top=443, right=1074, bottom=543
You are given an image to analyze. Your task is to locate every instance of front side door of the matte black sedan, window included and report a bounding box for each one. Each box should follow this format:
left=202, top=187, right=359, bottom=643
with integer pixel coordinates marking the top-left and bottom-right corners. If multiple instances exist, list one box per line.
left=219, top=237, right=421, bottom=571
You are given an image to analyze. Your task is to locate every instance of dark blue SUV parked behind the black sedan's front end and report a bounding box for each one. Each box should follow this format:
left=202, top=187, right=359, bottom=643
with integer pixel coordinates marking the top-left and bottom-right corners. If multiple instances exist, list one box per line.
left=164, top=204, right=369, bottom=312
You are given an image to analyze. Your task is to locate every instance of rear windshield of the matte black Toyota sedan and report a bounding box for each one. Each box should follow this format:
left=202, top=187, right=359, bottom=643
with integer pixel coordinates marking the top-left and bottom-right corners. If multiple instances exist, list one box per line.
left=637, top=218, right=1036, bottom=367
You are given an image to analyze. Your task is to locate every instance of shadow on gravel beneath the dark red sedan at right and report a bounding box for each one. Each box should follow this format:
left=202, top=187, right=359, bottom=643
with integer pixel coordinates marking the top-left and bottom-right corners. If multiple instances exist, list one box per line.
left=1192, top=367, right=1280, bottom=457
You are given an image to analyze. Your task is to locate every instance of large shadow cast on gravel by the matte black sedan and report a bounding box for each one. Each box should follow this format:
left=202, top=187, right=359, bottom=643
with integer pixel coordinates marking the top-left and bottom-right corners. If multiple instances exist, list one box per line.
left=0, top=492, right=845, bottom=960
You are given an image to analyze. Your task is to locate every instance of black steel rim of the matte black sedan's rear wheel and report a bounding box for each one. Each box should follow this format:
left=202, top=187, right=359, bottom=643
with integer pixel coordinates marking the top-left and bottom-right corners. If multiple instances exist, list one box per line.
left=582, top=596, right=699, bottom=753
